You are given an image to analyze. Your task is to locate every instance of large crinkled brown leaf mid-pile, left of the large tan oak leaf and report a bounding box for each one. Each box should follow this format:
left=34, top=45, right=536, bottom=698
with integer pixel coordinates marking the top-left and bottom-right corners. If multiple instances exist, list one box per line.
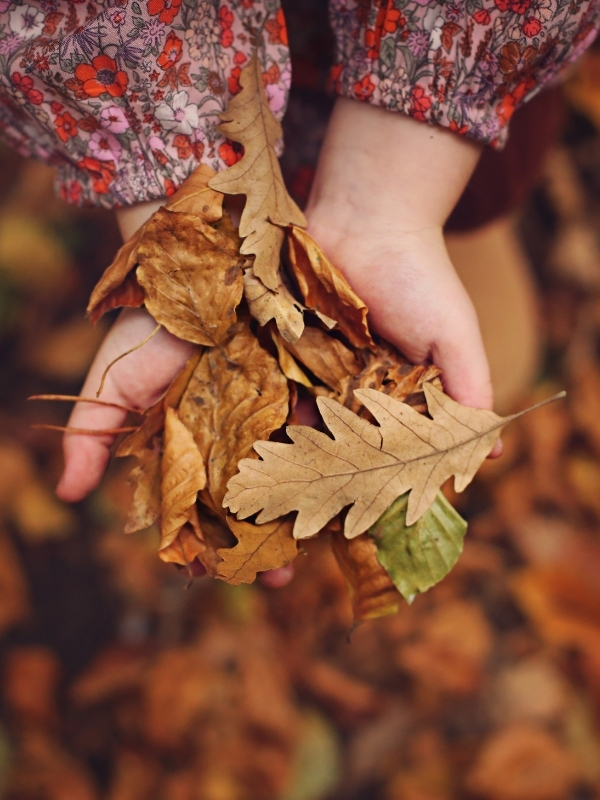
left=179, top=323, right=289, bottom=514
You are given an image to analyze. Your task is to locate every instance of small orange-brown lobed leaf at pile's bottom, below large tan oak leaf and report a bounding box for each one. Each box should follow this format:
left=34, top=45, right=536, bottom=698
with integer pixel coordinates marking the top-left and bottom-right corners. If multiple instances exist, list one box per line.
left=217, top=517, right=298, bottom=586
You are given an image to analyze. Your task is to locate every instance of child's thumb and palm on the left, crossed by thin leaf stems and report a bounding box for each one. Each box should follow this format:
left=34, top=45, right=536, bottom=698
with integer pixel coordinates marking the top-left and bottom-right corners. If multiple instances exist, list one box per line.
left=56, top=310, right=194, bottom=502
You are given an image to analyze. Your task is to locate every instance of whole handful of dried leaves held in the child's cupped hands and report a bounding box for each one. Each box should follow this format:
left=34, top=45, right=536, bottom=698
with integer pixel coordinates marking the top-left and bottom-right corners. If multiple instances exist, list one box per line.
left=82, top=58, right=560, bottom=620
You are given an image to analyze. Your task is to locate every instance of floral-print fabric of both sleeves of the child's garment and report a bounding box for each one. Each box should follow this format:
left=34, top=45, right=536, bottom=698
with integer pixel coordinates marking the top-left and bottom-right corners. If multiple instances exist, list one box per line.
left=0, top=0, right=600, bottom=207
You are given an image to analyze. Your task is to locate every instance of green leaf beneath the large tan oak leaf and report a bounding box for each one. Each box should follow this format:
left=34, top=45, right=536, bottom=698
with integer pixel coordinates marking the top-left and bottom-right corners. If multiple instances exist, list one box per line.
left=369, top=492, right=467, bottom=603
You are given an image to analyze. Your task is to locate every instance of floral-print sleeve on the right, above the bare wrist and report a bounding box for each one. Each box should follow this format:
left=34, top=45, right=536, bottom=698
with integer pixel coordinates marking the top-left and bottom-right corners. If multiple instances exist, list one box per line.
left=330, top=0, right=600, bottom=147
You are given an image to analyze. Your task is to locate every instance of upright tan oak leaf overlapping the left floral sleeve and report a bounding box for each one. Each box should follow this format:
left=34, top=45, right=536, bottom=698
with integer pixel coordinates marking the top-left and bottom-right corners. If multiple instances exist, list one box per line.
left=209, top=53, right=306, bottom=291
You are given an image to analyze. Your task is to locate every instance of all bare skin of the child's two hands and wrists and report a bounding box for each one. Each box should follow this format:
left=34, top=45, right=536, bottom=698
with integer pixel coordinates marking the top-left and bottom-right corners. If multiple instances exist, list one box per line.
left=57, top=99, right=501, bottom=586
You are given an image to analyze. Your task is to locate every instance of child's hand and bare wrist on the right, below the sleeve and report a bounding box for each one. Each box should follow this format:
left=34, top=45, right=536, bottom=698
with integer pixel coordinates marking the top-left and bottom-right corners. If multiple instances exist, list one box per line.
left=307, top=100, right=499, bottom=418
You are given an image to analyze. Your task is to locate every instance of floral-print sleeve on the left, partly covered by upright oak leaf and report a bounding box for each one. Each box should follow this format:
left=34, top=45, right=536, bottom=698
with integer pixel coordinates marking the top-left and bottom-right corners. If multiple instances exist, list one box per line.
left=0, top=0, right=290, bottom=208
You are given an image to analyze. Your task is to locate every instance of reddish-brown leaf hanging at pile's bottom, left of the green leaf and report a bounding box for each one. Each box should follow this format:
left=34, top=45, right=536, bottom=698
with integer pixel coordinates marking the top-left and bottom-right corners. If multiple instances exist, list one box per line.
left=331, top=528, right=402, bottom=622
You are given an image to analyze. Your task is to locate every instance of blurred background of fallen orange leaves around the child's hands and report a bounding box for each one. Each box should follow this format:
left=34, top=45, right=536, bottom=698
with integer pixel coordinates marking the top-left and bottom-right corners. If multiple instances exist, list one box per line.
left=0, top=10, right=600, bottom=800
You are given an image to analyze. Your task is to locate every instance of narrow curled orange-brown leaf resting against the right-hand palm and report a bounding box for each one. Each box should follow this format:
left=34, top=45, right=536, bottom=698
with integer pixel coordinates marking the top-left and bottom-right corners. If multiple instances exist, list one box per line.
left=288, top=225, right=375, bottom=347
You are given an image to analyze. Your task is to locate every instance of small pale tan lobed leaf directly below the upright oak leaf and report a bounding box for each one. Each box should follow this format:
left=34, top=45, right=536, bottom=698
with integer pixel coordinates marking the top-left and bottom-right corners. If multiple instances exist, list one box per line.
left=244, top=269, right=304, bottom=343
